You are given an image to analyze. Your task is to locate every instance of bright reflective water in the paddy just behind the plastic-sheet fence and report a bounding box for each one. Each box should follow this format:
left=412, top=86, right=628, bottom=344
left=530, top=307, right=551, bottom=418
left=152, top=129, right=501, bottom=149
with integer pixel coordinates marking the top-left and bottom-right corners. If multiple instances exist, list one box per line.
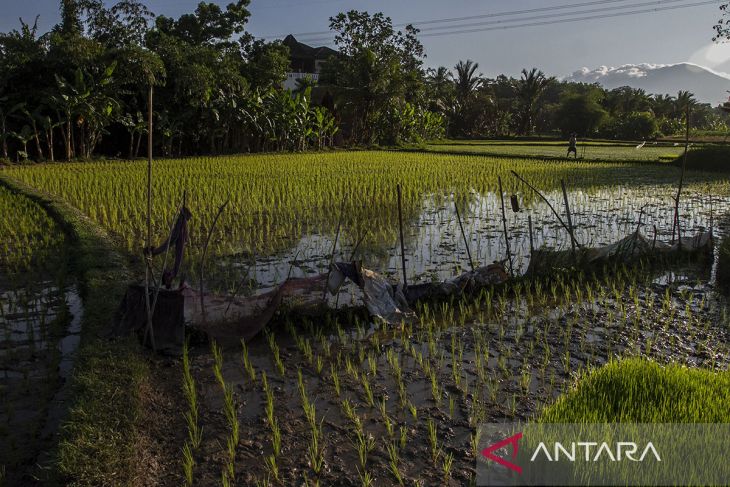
left=232, top=185, right=730, bottom=296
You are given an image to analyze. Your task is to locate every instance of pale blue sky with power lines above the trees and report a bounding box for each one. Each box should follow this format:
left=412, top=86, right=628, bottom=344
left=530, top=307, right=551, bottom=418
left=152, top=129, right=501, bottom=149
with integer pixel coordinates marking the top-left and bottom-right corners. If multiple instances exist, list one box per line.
left=0, top=0, right=730, bottom=77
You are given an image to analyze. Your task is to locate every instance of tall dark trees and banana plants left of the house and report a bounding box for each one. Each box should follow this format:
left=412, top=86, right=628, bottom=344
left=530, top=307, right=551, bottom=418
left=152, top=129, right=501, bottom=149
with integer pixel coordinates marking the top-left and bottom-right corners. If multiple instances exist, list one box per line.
left=0, top=0, right=337, bottom=160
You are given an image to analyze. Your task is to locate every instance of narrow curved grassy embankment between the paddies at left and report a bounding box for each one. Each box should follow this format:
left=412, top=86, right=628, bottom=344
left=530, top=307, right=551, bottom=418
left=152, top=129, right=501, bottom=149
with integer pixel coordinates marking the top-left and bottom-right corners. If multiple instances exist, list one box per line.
left=0, top=174, right=148, bottom=485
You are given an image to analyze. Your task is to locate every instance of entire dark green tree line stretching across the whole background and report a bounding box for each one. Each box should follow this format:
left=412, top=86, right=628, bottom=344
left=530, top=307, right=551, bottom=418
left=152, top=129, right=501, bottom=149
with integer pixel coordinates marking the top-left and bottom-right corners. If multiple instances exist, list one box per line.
left=0, top=0, right=727, bottom=164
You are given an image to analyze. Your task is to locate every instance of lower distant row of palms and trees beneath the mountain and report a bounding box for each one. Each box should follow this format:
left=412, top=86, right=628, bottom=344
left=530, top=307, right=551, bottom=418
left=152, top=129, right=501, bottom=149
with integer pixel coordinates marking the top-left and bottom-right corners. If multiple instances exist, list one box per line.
left=427, top=60, right=730, bottom=140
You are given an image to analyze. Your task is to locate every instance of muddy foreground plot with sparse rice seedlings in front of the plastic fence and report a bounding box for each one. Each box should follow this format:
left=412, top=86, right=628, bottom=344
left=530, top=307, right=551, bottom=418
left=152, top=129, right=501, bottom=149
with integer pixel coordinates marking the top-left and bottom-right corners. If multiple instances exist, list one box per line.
left=148, top=264, right=730, bottom=485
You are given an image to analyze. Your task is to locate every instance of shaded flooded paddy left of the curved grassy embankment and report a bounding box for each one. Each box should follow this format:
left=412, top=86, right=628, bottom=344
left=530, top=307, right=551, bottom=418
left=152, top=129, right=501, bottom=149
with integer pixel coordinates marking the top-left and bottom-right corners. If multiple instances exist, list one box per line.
left=0, top=188, right=83, bottom=485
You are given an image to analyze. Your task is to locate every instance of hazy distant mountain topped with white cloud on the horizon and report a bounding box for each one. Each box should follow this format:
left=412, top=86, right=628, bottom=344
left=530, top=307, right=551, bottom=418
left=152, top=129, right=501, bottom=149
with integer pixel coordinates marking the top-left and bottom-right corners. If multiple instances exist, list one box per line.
left=565, top=63, right=730, bottom=106
